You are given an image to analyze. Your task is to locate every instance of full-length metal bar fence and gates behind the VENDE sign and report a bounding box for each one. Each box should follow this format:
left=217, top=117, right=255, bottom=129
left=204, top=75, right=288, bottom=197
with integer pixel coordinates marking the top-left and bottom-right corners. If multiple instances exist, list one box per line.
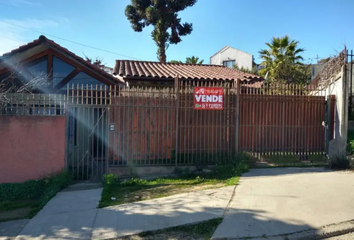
left=66, top=80, right=325, bottom=180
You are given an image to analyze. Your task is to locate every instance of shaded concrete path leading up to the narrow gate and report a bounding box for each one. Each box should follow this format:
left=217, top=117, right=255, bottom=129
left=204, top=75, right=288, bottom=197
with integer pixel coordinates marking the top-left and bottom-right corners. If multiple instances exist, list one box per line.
left=16, top=188, right=102, bottom=240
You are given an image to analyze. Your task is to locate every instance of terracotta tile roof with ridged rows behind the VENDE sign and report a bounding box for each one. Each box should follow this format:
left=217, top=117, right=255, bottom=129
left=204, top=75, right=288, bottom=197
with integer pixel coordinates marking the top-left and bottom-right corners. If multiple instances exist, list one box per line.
left=113, top=60, right=263, bottom=82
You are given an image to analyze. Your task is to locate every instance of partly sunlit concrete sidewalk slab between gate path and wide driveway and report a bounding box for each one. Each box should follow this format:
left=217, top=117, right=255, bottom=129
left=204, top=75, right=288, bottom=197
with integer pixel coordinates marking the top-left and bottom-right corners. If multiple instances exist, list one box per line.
left=92, top=186, right=234, bottom=239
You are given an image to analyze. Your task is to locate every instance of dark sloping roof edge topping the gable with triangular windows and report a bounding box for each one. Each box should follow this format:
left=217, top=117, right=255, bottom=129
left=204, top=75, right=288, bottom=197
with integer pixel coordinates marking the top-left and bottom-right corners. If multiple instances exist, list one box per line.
left=0, top=35, right=124, bottom=83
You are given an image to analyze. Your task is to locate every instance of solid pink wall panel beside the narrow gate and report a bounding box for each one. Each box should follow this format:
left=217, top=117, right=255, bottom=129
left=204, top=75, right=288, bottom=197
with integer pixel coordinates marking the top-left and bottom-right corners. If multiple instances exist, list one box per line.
left=0, top=116, right=65, bottom=183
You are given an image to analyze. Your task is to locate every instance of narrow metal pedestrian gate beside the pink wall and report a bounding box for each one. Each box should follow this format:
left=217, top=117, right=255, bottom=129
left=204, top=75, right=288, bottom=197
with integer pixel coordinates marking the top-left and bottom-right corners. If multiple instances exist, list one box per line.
left=66, top=86, right=109, bottom=181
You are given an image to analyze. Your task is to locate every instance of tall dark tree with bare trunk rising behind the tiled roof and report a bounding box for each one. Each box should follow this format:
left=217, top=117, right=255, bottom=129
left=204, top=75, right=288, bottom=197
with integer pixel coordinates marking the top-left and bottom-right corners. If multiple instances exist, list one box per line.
left=125, top=0, right=197, bottom=63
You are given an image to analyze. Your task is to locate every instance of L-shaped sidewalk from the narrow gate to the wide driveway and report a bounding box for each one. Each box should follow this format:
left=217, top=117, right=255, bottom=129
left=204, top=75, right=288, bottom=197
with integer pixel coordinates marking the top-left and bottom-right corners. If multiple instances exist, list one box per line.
left=16, top=186, right=235, bottom=240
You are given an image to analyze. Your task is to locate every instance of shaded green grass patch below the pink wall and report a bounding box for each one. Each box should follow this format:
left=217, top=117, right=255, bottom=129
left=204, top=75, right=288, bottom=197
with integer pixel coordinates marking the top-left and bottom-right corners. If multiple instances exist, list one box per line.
left=0, top=170, right=71, bottom=222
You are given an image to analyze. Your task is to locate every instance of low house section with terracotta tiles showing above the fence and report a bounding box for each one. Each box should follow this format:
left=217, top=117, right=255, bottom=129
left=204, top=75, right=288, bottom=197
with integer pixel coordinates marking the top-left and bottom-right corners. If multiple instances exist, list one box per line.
left=113, top=60, right=263, bottom=86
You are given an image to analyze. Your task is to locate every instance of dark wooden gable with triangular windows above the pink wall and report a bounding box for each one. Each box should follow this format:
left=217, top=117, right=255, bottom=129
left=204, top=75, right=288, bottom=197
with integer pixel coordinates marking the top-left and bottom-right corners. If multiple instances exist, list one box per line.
left=0, top=36, right=124, bottom=94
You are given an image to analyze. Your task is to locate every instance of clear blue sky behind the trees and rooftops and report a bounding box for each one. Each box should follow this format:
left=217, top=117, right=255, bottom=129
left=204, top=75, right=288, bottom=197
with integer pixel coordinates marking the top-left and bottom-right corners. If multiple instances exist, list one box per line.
left=0, top=0, right=354, bottom=67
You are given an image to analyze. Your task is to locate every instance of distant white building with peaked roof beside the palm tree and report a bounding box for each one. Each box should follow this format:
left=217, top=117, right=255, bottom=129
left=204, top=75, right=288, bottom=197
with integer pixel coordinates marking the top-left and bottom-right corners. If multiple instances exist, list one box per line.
left=210, top=46, right=253, bottom=70
